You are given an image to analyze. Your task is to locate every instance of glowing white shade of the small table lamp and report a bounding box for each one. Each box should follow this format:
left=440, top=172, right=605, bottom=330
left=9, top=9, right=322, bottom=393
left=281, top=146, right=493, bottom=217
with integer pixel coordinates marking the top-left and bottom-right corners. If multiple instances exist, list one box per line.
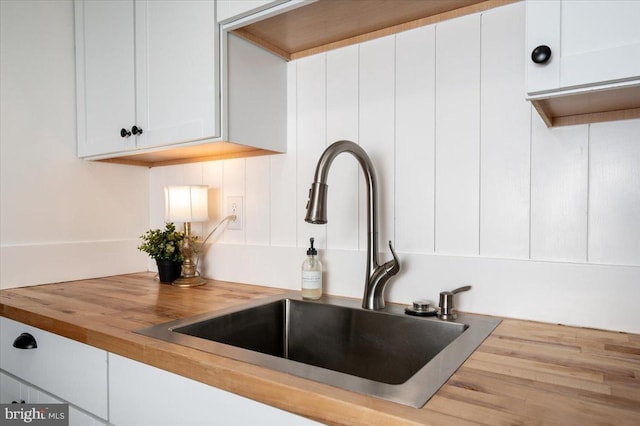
left=164, top=185, right=209, bottom=222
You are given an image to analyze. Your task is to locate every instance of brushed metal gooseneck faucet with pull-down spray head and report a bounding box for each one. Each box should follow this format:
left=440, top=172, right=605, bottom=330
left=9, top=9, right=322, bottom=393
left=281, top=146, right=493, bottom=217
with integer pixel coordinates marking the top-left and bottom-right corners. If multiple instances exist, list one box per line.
left=304, top=141, right=400, bottom=310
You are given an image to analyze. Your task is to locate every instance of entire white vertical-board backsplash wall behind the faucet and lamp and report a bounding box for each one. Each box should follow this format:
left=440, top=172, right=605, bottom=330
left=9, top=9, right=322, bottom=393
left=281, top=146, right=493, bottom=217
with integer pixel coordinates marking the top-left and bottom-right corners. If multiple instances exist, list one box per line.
left=150, top=3, right=640, bottom=332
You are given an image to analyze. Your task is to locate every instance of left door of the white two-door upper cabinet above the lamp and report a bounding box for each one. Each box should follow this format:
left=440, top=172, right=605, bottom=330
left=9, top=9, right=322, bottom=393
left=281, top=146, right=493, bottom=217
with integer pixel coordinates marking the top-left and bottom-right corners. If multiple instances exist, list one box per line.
left=75, top=0, right=135, bottom=157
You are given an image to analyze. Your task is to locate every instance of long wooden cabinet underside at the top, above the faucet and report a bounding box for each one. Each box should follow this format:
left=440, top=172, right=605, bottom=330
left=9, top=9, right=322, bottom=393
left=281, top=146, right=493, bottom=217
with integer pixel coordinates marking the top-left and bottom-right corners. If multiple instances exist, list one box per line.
left=232, top=0, right=518, bottom=61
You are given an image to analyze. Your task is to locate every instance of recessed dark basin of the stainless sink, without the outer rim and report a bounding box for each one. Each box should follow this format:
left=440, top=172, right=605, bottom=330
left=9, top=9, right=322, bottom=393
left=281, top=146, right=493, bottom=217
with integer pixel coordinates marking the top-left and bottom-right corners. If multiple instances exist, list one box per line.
left=173, top=299, right=467, bottom=385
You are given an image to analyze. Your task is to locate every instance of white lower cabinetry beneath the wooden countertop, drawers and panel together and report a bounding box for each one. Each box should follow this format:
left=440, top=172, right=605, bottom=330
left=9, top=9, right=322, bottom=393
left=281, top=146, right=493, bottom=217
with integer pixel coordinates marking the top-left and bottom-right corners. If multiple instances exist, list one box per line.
left=0, top=317, right=318, bottom=426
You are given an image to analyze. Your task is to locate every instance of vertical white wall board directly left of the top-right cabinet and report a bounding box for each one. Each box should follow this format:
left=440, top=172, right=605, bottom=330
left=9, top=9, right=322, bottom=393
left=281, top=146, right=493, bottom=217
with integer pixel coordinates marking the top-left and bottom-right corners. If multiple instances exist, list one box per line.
left=479, top=8, right=532, bottom=259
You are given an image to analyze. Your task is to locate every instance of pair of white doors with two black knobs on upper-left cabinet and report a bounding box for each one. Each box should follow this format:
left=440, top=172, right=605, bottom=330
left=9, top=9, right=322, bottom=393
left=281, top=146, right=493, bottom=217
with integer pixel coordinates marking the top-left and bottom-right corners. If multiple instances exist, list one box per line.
left=75, top=0, right=220, bottom=157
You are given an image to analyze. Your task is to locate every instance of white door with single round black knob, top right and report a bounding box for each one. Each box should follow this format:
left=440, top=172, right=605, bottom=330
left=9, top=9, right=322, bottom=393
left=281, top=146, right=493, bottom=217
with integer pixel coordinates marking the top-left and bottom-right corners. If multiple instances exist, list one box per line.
left=526, top=0, right=640, bottom=95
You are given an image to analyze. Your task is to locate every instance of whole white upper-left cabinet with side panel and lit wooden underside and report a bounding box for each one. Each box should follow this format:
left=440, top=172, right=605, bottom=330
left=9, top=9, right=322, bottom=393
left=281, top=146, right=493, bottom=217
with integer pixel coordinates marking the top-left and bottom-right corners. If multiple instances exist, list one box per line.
left=75, top=0, right=286, bottom=166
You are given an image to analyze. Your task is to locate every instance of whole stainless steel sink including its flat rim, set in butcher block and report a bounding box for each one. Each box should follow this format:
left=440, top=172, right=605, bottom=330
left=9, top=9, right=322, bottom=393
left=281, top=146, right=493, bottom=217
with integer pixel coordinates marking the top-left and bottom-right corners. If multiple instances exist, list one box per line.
left=137, top=295, right=500, bottom=407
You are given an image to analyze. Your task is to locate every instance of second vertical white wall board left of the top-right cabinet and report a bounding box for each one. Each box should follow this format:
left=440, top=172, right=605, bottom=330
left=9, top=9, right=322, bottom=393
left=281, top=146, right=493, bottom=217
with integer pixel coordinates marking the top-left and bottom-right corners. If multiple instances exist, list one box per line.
left=436, top=15, right=481, bottom=255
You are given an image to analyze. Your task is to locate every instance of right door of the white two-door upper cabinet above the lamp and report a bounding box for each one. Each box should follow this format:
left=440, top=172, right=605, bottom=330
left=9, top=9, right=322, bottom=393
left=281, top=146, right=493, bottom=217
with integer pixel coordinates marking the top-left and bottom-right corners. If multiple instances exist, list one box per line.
left=135, top=0, right=220, bottom=148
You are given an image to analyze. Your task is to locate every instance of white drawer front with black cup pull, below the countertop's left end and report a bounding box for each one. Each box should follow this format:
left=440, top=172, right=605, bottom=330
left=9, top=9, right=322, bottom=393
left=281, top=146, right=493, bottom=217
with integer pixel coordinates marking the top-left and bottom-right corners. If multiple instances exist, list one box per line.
left=0, top=317, right=108, bottom=419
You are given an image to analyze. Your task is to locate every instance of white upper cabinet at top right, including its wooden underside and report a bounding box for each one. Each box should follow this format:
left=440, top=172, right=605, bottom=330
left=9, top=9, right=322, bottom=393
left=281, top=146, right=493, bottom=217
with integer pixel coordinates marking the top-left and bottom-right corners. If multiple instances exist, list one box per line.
left=526, top=0, right=640, bottom=124
